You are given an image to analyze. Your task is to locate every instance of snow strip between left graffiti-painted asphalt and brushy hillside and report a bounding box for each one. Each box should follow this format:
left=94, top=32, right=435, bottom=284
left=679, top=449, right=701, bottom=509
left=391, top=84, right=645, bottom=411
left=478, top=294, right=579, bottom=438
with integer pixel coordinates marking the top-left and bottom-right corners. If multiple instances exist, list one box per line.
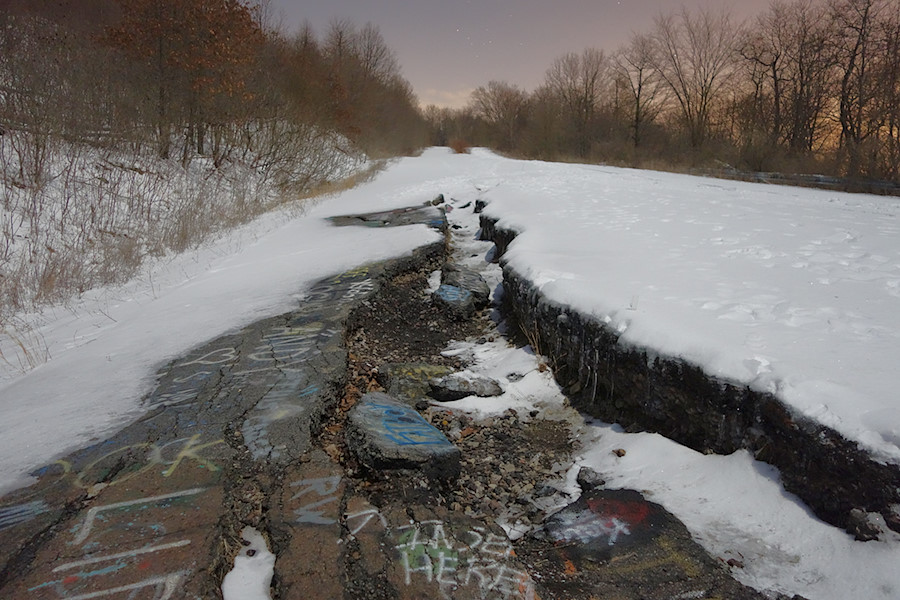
left=0, top=154, right=467, bottom=493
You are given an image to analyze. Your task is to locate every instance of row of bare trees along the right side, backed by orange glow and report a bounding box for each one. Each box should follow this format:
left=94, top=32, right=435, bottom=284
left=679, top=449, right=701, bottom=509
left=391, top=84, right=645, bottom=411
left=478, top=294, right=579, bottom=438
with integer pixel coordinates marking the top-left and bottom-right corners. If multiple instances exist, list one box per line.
left=426, top=0, right=900, bottom=181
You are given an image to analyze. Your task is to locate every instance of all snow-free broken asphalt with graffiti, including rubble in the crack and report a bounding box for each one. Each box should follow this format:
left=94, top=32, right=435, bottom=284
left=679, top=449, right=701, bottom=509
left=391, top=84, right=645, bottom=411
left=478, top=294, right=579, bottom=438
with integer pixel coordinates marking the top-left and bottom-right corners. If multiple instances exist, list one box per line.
left=0, top=202, right=762, bottom=600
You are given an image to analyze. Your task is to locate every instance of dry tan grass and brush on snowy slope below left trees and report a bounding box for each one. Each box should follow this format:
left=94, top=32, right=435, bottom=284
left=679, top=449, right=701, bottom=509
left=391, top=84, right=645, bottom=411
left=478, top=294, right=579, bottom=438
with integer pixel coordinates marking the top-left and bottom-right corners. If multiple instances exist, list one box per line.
left=0, top=131, right=376, bottom=352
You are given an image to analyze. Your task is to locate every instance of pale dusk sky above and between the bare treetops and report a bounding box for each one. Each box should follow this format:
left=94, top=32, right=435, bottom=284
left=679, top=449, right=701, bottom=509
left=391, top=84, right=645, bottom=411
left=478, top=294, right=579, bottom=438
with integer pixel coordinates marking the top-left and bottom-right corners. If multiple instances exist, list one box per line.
left=271, top=0, right=769, bottom=106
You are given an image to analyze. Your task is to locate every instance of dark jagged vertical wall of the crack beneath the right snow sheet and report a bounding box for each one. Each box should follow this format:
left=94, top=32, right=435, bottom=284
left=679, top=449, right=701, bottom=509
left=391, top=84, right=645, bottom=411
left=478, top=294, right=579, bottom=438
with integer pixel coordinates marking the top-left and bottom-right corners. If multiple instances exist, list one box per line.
left=481, top=215, right=900, bottom=536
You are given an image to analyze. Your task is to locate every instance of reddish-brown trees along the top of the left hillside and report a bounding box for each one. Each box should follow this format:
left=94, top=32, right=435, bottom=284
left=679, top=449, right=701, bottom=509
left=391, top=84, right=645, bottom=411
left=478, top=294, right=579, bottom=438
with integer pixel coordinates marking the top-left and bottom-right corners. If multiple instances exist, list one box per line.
left=0, top=0, right=424, bottom=182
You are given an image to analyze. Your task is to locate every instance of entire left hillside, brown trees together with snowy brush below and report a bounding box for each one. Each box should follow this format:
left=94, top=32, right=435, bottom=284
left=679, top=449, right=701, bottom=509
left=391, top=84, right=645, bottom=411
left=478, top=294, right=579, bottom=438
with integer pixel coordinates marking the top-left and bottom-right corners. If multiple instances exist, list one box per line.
left=0, top=0, right=427, bottom=324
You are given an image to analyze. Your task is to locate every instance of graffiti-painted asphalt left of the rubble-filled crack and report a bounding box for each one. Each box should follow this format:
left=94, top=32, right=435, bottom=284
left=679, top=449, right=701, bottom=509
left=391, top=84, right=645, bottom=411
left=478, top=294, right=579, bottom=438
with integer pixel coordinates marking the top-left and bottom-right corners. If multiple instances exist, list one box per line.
left=0, top=224, right=446, bottom=598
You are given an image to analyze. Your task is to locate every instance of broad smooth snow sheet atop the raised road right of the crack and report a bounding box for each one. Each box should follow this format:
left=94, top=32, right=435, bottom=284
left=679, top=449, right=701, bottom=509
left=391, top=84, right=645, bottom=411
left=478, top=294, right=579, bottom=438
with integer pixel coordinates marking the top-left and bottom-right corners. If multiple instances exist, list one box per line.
left=484, top=163, right=900, bottom=464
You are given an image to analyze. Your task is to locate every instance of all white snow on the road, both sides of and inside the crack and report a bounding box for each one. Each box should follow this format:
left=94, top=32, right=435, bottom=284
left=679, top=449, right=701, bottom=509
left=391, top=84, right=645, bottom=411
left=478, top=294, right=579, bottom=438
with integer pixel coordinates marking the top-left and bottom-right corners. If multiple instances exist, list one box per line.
left=0, top=149, right=900, bottom=600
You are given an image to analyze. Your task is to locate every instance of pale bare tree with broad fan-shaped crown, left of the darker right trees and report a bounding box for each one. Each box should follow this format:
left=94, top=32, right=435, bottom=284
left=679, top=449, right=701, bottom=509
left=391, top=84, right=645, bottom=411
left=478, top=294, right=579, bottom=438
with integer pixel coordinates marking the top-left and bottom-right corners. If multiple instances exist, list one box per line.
left=653, top=8, right=740, bottom=147
